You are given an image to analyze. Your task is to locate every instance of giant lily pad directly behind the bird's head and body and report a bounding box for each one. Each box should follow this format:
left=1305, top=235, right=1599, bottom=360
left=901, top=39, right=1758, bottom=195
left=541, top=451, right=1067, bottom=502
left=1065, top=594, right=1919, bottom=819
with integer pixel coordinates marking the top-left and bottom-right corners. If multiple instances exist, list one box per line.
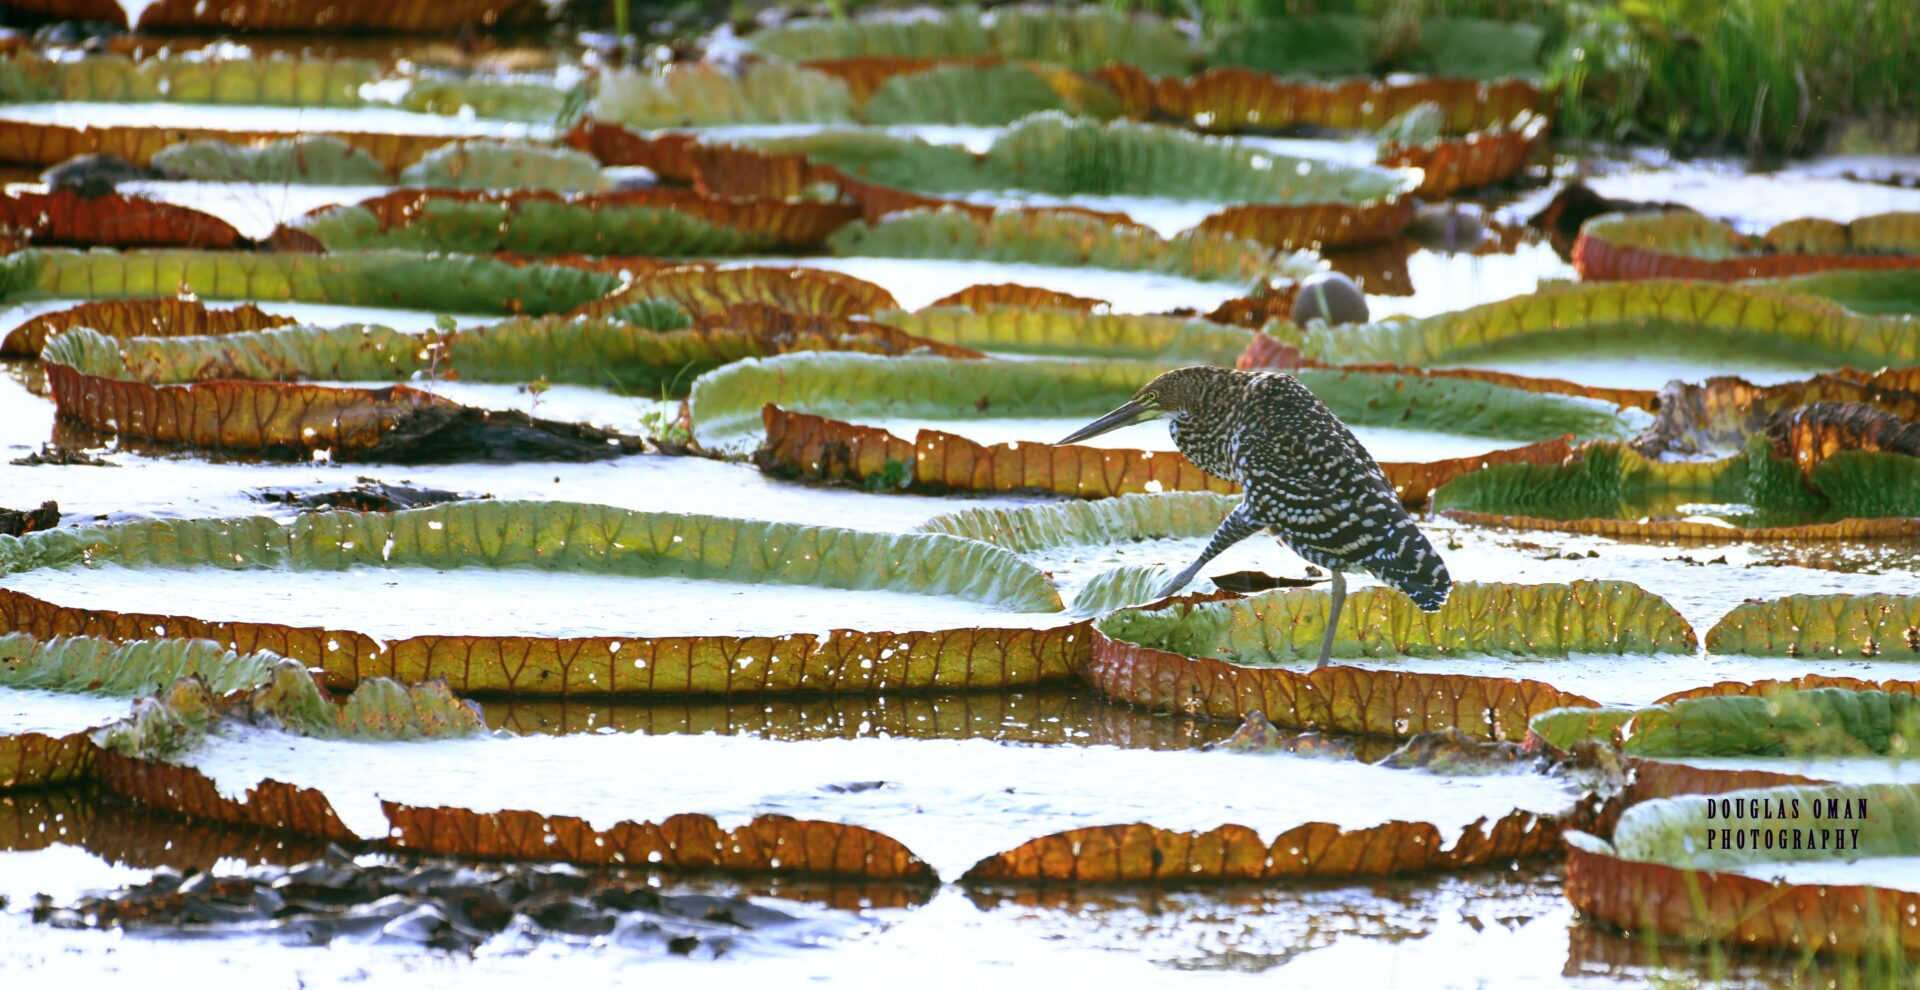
left=689, top=357, right=1620, bottom=503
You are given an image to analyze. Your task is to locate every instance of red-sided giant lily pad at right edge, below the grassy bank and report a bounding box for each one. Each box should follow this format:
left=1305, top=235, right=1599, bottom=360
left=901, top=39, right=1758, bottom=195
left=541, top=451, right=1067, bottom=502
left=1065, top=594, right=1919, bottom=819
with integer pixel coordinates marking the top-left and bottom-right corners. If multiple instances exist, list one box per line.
left=1572, top=211, right=1920, bottom=282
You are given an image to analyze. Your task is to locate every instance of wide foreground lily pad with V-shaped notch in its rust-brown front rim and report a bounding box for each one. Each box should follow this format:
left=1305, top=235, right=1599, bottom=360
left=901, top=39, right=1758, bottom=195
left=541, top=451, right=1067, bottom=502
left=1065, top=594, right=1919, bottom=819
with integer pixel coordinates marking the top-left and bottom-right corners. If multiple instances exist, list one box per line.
left=165, top=735, right=1572, bottom=881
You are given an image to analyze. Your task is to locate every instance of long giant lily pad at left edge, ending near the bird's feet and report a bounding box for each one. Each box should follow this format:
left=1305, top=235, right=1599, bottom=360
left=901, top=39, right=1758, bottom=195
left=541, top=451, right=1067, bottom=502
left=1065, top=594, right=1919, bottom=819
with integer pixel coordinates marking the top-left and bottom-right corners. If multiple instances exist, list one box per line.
left=0, top=501, right=1087, bottom=695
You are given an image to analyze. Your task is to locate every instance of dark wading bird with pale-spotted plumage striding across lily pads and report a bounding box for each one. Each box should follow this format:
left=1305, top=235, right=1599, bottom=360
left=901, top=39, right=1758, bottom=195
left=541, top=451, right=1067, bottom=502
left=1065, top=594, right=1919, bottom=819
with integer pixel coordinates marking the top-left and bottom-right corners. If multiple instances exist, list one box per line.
left=1060, top=366, right=1453, bottom=666
